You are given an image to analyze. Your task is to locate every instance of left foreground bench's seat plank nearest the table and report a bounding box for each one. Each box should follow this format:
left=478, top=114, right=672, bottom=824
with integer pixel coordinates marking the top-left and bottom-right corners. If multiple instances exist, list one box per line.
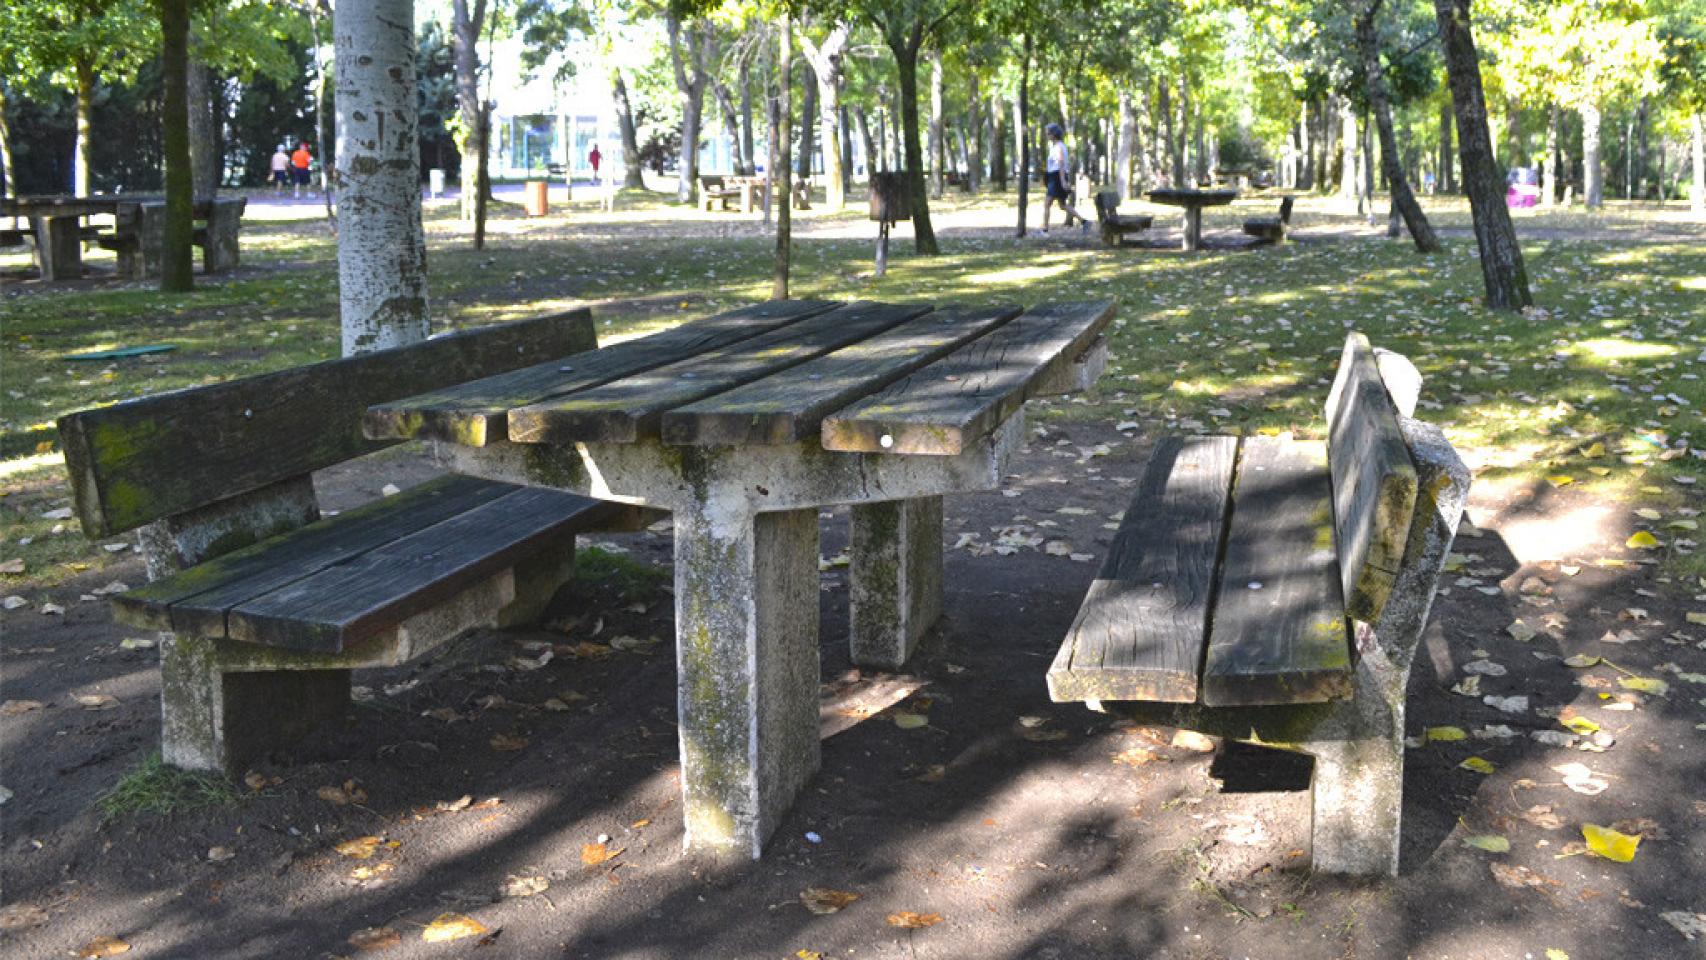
left=227, top=489, right=601, bottom=653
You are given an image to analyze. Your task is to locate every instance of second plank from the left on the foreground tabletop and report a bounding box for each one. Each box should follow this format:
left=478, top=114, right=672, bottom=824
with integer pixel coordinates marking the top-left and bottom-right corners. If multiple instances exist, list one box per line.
left=508, top=302, right=930, bottom=443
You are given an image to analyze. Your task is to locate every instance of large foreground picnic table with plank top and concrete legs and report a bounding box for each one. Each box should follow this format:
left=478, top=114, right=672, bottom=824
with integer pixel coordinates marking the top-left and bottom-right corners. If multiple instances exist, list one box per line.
left=365, top=300, right=1114, bottom=858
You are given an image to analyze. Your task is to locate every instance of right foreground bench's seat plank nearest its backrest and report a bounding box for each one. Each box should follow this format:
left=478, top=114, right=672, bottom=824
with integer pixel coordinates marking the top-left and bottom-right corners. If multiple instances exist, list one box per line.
left=1203, top=437, right=1351, bottom=706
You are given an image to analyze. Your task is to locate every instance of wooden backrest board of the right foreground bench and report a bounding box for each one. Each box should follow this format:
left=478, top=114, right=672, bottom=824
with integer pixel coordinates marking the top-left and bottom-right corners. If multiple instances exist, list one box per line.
left=1326, top=333, right=1416, bottom=622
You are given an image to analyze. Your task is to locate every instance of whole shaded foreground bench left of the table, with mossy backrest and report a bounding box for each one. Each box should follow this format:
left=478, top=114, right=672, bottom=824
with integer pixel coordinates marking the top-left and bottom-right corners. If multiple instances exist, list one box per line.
left=60, top=310, right=640, bottom=772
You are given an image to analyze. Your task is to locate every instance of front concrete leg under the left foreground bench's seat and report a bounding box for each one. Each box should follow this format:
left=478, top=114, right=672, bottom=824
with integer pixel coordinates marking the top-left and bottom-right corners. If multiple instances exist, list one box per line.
left=160, top=634, right=350, bottom=776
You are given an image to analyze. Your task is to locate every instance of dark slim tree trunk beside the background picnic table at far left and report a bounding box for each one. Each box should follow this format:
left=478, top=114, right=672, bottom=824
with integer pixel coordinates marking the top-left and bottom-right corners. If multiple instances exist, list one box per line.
left=159, top=0, right=196, bottom=293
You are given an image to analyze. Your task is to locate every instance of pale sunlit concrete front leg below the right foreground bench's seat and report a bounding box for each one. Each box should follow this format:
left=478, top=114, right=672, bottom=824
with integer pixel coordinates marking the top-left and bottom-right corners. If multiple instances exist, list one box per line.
left=1302, top=737, right=1404, bottom=876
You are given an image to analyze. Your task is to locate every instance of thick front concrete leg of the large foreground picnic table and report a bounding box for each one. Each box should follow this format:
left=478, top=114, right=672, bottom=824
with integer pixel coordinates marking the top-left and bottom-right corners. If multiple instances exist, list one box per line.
left=676, top=501, right=819, bottom=859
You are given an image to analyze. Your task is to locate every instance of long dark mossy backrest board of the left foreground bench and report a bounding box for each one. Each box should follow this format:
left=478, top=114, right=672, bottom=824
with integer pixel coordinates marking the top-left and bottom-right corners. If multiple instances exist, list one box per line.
left=60, top=309, right=597, bottom=537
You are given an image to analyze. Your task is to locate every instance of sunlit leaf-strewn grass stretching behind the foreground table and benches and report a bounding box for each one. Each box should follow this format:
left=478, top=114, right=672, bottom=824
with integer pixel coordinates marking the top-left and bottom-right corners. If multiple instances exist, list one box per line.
left=0, top=187, right=1706, bottom=583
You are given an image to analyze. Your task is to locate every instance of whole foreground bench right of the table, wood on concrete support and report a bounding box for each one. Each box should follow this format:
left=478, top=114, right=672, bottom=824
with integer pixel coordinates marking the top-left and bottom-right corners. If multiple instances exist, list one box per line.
left=1047, top=333, right=1469, bottom=875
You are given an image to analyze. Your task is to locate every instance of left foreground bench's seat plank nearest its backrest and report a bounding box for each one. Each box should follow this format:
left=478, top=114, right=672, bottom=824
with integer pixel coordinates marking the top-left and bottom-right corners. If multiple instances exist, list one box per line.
left=113, top=476, right=519, bottom=636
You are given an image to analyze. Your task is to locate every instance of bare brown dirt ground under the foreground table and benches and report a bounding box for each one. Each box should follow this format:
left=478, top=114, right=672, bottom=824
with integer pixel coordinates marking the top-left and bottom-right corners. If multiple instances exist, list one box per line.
left=0, top=410, right=1706, bottom=960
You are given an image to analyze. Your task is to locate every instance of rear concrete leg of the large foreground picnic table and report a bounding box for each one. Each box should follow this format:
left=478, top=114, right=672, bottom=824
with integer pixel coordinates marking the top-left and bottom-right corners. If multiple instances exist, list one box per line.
left=850, top=496, right=942, bottom=670
